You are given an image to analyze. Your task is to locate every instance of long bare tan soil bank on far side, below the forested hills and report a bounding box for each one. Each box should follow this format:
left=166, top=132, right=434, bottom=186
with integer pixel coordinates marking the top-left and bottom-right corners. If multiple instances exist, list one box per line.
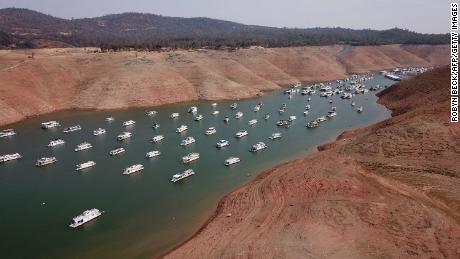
left=0, top=45, right=449, bottom=125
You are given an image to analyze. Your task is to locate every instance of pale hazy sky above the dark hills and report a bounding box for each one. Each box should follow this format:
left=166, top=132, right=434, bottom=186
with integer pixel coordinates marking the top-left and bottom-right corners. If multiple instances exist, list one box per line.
left=0, top=0, right=451, bottom=33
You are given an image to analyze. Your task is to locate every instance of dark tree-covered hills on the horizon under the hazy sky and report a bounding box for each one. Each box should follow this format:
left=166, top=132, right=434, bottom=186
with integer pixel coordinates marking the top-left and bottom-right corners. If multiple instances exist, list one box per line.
left=0, top=8, right=449, bottom=49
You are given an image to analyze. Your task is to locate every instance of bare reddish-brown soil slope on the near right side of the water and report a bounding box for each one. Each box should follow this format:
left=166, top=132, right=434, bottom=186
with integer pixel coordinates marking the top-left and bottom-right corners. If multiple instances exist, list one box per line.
left=166, top=68, right=460, bottom=258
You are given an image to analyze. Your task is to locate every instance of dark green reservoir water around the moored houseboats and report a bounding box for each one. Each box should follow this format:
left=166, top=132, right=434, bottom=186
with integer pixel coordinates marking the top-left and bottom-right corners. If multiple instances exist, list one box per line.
left=0, top=75, right=392, bottom=258
